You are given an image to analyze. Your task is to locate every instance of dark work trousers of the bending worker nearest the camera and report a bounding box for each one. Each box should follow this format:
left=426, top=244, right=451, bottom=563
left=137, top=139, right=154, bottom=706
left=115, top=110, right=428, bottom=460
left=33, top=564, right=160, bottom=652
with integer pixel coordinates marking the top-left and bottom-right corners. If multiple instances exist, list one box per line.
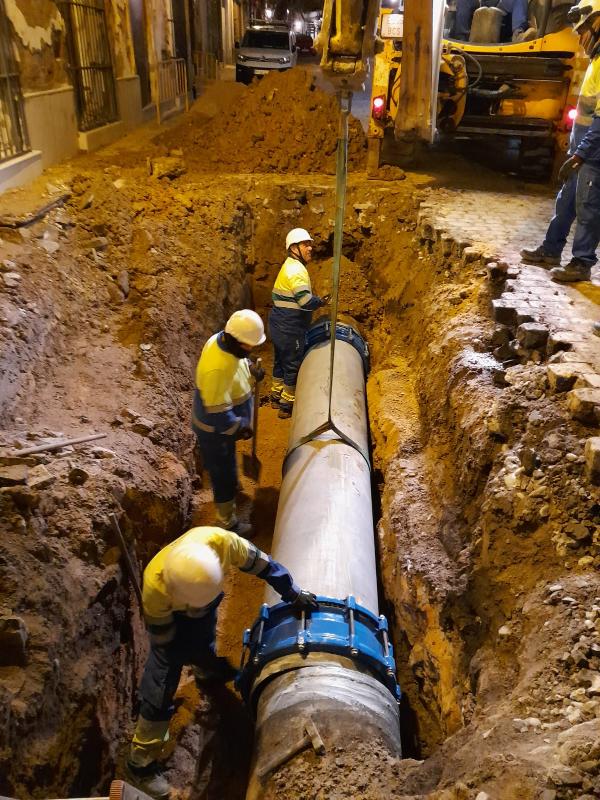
left=139, top=608, right=223, bottom=722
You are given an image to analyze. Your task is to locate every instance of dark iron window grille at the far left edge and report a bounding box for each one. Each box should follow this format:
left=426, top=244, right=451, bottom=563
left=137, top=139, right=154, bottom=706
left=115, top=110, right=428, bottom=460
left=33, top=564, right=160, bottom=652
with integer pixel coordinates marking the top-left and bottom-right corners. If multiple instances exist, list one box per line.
left=0, top=0, right=30, bottom=162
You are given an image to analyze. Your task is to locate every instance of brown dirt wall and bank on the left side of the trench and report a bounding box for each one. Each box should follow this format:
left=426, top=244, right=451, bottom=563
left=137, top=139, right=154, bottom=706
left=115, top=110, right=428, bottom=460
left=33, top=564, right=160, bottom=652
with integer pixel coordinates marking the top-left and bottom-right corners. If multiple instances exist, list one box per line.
left=0, top=165, right=249, bottom=797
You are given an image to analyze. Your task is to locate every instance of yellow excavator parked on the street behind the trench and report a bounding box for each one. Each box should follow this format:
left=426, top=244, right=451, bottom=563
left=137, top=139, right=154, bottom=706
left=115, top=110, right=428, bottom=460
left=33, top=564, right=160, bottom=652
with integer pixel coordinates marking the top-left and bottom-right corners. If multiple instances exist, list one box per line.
left=320, top=0, right=587, bottom=177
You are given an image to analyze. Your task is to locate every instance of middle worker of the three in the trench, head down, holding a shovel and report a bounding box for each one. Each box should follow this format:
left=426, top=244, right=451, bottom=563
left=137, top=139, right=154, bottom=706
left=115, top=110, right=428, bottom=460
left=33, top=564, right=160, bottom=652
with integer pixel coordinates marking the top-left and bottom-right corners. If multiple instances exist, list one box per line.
left=192, top=309, right=265, bottom=536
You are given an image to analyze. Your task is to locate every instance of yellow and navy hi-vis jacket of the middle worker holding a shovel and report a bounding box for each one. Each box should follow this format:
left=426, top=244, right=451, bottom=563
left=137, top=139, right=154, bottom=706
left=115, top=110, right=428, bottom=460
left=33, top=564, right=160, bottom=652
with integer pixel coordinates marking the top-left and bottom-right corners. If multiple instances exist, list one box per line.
left=192, top=331, right=252, bottom=436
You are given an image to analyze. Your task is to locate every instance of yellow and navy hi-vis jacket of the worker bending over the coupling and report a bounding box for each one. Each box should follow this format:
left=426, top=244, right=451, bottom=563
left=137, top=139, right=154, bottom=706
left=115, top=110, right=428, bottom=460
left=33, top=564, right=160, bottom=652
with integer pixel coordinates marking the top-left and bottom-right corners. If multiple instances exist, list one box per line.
left=142, top=526, right=300, bottom=644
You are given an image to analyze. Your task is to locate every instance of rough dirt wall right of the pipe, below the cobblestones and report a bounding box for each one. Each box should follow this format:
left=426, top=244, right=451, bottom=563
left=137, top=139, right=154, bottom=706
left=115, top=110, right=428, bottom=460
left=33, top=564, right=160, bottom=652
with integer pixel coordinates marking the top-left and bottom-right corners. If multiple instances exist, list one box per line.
left=369, top=203, right=600, bottom=798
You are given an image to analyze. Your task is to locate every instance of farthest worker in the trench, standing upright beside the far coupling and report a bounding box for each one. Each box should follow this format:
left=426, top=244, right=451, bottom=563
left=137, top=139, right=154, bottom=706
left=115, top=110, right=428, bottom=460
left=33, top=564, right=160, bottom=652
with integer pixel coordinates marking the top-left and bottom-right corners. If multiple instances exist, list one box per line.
left=269, top=228, right=329, bottom=419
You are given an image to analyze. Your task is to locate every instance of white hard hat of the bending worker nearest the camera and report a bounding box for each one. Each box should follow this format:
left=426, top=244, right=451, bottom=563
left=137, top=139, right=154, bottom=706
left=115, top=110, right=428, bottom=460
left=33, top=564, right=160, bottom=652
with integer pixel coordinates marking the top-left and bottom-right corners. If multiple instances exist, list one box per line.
left=162, top=539, right=223, bottom=608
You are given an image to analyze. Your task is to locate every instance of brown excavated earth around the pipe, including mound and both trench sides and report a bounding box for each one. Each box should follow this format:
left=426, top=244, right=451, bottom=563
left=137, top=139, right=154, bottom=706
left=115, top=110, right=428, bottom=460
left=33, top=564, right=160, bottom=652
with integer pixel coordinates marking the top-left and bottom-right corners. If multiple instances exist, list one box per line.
left=0, top=69, right=600, bottom=800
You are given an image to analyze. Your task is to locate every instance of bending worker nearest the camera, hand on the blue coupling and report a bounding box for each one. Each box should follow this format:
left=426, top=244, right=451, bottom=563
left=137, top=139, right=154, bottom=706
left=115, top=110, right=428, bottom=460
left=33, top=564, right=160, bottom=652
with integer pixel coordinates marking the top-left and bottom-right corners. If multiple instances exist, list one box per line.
left=127, top=527, right=317, bottom=798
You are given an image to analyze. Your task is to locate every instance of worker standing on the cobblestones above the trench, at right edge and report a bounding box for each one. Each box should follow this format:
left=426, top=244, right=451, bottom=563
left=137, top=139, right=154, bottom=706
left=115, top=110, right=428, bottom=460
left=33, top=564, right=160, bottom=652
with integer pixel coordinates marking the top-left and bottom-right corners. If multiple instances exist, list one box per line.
left=521, top=0, right=600, bottom=282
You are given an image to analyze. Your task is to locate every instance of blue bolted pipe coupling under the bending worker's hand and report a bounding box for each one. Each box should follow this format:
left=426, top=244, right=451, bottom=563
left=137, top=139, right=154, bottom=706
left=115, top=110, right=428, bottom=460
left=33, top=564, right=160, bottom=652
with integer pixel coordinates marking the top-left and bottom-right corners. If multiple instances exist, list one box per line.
left=236, top=595, right=401, bottom=704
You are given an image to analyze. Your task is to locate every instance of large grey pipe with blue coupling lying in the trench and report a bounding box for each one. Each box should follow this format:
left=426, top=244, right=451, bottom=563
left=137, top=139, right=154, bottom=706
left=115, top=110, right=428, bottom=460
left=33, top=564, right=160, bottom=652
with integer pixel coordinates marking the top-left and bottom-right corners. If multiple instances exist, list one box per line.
left=240, top=325, right=400, bottom=800
